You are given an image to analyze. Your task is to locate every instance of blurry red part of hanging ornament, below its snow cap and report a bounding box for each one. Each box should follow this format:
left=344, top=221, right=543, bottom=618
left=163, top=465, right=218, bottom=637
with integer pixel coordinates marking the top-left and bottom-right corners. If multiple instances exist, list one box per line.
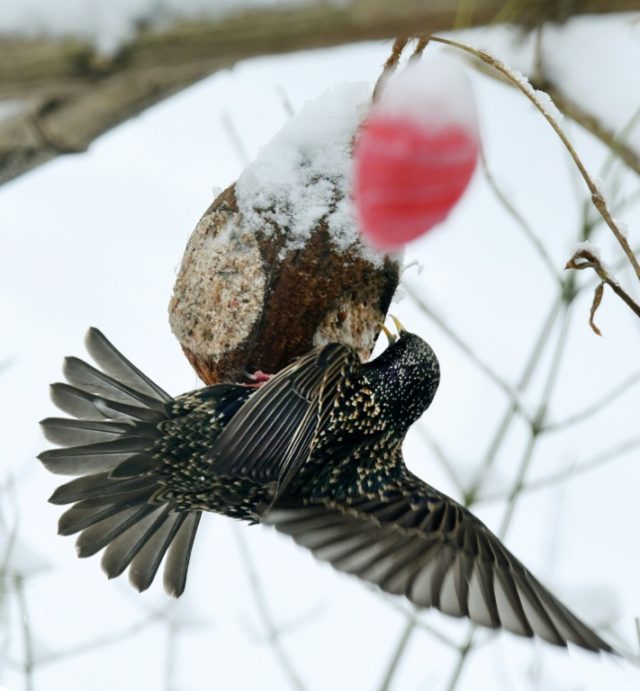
left=354, top=115, right=479, bottom=251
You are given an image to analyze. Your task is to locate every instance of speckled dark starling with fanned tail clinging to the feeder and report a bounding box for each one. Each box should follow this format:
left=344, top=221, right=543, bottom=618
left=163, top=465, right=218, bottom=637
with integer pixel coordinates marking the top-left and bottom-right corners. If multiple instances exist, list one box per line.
left=39, top=325, right=613, bottom=652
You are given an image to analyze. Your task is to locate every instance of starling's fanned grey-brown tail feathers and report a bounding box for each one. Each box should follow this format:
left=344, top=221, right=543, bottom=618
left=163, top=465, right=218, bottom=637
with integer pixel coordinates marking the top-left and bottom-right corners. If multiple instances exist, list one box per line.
left=38, top=328, right=200, bottom=597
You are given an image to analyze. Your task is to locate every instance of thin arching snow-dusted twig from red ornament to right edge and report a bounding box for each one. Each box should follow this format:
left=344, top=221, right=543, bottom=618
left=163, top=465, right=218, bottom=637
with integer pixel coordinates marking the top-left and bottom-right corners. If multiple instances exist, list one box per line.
left=431, top=36, right=640, bottom=280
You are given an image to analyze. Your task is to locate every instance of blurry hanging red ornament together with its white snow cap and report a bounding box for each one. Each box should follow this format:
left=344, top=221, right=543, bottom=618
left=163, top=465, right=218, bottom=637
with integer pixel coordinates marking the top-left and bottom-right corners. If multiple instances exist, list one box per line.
left=354, top=59, right=480, bottom=251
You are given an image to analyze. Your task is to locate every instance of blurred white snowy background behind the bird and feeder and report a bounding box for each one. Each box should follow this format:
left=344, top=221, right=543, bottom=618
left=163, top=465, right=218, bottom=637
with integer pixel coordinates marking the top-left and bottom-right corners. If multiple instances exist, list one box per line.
left=0, top=3, right=640, bottom=691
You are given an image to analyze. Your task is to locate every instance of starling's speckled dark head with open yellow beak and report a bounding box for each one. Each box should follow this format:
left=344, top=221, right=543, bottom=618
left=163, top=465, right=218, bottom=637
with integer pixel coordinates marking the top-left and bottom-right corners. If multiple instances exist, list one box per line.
left=363, top=317, right=440, bottom=430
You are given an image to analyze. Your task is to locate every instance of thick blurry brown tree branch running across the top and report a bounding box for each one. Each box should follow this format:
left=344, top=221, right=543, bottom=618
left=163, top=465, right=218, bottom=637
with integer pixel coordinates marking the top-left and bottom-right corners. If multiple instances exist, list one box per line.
left=0, top=0, right=637, bottom=183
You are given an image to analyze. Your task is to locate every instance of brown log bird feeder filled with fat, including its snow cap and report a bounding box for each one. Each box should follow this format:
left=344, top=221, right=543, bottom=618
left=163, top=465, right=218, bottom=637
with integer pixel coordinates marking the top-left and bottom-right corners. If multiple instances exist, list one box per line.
left=169, top=83, right=399, bottom=384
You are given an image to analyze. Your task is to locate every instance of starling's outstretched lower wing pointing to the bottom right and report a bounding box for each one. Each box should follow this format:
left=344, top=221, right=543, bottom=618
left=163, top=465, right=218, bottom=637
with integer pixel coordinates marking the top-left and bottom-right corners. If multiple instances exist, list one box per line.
left=263, top=474, right=612, bottom=652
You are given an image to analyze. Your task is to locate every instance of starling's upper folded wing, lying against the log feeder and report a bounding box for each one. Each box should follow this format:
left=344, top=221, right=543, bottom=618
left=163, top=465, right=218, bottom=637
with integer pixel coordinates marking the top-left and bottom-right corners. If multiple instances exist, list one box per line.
left=208, top=344, right=359, bottom=493
